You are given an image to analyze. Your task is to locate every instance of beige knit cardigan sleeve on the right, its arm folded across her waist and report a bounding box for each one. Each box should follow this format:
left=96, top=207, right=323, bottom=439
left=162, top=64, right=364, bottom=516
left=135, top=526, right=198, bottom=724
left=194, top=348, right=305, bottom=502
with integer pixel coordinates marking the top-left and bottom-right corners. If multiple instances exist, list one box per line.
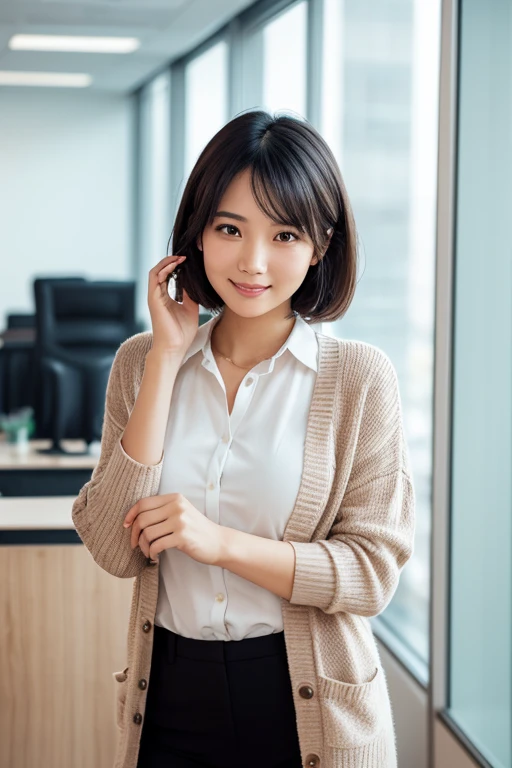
left=290, top=352, right=415, bottom=616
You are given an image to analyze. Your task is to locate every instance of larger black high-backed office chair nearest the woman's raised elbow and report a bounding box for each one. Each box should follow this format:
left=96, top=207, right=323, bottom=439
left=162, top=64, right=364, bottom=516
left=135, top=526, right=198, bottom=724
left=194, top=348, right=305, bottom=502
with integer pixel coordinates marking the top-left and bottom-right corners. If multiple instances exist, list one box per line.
left=34, top=278, right=138, bottom=455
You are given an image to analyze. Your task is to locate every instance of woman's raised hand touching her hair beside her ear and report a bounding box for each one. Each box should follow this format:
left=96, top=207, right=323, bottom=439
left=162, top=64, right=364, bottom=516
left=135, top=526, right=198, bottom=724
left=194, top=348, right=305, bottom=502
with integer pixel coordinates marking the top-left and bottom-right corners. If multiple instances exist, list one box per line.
left=148, top=255, right=199, bottom=360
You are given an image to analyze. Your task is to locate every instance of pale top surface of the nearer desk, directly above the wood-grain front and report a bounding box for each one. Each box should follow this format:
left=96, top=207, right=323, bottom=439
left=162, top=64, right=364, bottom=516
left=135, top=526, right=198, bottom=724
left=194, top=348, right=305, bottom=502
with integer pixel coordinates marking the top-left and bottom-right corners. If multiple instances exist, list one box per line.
left=0, top=496, right=76, bottom=531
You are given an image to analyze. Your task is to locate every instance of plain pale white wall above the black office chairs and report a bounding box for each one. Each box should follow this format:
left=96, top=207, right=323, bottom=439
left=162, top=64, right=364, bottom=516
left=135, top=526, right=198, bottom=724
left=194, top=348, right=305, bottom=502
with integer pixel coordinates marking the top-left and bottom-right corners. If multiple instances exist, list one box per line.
left=0, top=87, right=135, bottom=329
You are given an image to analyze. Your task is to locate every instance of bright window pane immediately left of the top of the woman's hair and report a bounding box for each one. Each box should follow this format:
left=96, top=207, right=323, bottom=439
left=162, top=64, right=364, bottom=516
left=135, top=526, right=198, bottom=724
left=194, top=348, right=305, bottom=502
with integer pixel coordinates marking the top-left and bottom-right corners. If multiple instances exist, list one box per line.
left=185, top=40, right=228, bottom=179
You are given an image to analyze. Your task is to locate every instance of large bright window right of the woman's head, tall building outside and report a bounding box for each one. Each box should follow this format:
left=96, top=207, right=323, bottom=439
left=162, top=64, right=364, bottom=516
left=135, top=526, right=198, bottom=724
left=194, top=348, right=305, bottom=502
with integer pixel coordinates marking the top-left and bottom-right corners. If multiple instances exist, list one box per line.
left=319, top=0, right=440, bottom=681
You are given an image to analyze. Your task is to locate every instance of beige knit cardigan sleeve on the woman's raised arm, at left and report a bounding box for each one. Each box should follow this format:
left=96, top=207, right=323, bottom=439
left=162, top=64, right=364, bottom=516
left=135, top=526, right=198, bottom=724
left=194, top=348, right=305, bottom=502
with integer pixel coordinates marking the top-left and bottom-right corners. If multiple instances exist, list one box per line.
left=72, top=334, right=163, bottom=578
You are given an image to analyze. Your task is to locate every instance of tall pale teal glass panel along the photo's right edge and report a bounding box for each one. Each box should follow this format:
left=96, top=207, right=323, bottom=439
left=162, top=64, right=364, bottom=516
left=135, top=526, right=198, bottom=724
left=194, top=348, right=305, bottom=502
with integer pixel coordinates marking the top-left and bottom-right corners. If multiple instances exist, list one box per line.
left=448, top=0, right=512, bottom=768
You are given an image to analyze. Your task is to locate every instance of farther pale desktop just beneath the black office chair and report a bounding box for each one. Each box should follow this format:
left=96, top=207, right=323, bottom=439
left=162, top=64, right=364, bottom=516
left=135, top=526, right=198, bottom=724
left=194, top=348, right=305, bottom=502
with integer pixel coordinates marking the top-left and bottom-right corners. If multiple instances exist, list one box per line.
left=0, top=434, right=98, bottom=471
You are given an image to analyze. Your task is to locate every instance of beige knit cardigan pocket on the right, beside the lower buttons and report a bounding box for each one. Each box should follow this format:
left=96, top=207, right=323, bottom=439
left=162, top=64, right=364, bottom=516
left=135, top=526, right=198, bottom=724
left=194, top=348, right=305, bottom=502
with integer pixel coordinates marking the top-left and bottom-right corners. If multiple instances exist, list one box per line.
left=318, top=667, right=387, bottom=749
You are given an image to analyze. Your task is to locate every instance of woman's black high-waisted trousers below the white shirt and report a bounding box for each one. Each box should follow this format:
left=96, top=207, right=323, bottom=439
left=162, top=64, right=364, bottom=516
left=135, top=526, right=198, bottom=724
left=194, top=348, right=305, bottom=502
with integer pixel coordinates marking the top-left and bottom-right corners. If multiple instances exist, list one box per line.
left=137, top=625, right=302, bottom=768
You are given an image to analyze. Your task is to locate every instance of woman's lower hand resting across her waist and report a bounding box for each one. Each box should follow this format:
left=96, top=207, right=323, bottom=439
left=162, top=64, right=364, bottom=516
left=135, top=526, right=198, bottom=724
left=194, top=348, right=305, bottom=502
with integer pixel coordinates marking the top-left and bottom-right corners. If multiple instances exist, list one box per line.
left=124, top=493, right=222, bottom=565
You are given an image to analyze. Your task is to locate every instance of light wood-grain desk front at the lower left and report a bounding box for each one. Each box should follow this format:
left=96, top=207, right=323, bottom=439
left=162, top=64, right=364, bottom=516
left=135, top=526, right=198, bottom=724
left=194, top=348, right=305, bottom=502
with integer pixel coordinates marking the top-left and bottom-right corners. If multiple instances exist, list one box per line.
left=0, top=544, right=134, bottom=768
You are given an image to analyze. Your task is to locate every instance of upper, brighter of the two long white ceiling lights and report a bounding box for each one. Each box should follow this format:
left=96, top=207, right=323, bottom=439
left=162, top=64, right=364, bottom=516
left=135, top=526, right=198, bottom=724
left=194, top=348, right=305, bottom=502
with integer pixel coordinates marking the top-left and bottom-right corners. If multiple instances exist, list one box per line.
left=9, top=35, right=140, bottom=53
